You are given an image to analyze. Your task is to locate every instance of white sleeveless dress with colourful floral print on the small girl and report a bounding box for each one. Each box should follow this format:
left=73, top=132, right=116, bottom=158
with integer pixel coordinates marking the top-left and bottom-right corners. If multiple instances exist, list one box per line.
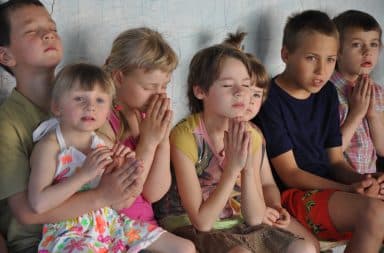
left=34, top=119, right=165, bottom=253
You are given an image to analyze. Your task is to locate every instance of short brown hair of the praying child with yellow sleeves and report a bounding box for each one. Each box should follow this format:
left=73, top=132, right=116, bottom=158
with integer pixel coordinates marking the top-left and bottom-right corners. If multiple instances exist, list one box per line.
left=188, top=45, right=252, bottom=113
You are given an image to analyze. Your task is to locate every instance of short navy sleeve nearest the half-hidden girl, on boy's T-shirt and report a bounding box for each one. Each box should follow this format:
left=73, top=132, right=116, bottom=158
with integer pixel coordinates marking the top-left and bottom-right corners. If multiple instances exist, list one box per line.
left=255, top=94, right=293, bottom=158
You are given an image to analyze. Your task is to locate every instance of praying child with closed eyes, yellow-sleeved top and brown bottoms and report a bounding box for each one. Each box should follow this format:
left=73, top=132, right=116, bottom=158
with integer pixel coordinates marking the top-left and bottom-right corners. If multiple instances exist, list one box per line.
left=157, top=45, right=315, bottom=252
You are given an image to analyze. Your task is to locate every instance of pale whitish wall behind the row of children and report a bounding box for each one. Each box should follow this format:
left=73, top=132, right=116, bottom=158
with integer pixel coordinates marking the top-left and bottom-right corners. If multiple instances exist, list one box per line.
left=0, top=0, right=384, bottom=121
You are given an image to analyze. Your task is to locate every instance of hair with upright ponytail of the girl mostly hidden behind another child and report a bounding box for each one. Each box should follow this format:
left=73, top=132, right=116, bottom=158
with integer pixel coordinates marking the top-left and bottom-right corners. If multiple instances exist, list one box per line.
left=222, top=30, right=270, bottom=101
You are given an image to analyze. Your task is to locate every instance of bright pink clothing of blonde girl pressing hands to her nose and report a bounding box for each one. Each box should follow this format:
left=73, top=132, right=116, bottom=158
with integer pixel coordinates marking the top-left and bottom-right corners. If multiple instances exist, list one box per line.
left=108, top=111, right=157, bottom=225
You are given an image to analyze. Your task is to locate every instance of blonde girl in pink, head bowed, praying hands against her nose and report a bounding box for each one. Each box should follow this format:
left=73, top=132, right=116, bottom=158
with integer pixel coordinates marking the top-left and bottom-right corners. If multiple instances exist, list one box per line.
left=104, top=28, right=195, bottom=252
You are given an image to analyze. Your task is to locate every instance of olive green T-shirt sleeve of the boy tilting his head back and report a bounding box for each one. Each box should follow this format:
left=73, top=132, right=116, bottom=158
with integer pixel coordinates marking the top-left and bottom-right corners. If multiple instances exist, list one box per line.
left=0, top=119, right=30, bottom=199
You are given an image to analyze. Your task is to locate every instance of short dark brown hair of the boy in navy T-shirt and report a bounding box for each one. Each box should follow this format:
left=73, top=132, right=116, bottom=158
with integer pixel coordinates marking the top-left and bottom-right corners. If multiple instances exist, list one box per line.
left=283, top=10, right=339, bottom=52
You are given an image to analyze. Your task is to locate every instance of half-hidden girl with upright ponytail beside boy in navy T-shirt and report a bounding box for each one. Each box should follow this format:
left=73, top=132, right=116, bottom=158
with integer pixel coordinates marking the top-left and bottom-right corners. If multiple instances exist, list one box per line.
left=223, top=32, right=320, bottom=252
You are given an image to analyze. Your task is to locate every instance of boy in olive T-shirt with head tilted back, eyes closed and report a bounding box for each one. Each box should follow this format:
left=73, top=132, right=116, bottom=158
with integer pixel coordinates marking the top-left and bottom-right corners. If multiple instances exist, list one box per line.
left=0, top=0, right=138, bottom=253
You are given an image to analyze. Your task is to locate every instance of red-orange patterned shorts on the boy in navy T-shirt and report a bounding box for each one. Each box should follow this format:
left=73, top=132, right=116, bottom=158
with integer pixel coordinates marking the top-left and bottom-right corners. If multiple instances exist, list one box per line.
left=281, top=189, right=352, bottom=241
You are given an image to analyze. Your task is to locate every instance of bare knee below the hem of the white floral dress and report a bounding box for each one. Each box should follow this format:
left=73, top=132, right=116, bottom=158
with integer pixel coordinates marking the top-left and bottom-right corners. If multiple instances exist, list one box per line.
left=147, top=232, right=196, bottom=253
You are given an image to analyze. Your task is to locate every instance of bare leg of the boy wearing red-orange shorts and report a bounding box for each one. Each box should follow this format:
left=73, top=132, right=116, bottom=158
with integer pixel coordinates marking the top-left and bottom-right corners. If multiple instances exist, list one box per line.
left=328, top=192, right=384, bottom=253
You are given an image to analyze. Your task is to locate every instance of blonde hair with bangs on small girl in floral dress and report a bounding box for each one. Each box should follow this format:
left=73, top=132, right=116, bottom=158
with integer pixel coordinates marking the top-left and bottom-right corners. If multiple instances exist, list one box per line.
left=52, top=63, right=115, bottom=102
